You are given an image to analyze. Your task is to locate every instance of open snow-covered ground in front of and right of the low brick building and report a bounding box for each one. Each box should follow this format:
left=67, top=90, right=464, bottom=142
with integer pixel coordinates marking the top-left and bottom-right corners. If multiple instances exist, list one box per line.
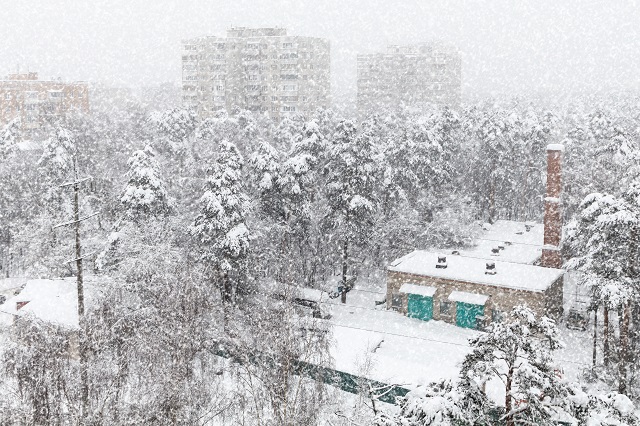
left=324, top=289, right=591, bottom=388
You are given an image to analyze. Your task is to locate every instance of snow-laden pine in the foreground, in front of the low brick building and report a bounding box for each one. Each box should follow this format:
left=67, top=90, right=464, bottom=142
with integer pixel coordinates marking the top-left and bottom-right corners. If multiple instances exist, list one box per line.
left=459, top=306, right=568, bottom=426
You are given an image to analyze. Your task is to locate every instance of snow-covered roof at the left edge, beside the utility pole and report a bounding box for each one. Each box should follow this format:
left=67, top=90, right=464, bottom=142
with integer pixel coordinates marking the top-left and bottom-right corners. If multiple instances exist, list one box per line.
left=0, top=277, right=97, bottom=329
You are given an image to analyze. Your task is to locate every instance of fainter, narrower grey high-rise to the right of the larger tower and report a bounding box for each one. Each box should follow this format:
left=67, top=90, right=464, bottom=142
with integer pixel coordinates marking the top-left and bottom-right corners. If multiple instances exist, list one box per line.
left=358, top=43, right=461, bottom=115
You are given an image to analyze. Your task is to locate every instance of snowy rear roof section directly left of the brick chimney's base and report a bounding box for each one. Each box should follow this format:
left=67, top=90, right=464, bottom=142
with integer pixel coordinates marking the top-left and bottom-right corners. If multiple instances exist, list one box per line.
left=458, top=220, right=544, bottom=264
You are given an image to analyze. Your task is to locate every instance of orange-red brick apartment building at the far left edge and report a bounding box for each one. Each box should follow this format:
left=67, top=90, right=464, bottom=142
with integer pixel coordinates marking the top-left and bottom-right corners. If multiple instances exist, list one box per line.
left=0, top=72, right=89, bottom=132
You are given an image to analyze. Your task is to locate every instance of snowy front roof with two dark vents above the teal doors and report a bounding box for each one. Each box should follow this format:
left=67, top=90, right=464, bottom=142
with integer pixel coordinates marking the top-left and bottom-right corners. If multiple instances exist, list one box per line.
left=389, top=250, right=564, bottom=292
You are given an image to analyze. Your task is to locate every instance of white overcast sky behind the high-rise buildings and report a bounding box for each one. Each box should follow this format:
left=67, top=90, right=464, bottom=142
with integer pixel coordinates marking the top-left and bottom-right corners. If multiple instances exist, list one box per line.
left=0, top=0, right=640, bottom=99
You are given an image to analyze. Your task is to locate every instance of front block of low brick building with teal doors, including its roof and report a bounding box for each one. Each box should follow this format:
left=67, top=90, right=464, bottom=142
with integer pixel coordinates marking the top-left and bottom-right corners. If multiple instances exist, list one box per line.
left=387, top=250, right=564, bottom=328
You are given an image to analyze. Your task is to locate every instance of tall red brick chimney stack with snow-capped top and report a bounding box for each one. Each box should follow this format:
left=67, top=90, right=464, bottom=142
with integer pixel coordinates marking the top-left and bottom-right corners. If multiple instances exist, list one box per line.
left=540, top=144, right=564, bottom=268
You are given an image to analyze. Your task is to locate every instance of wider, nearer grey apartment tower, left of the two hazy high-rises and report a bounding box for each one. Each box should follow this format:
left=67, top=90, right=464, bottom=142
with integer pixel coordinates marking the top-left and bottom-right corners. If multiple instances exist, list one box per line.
left=182, top=28, right=331, bottom=121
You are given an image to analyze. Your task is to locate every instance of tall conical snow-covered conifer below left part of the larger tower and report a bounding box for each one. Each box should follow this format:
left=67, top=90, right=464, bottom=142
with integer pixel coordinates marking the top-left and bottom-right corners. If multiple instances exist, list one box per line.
left=190, top=141, right=250, bottom=302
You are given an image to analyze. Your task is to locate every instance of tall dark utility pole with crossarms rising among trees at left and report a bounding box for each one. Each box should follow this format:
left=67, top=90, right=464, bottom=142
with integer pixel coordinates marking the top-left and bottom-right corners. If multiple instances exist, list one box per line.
left=54, top=155, right=98, bottom=424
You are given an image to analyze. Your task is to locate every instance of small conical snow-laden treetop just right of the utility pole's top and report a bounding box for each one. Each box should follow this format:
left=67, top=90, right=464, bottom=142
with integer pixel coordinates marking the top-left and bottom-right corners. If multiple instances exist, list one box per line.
left=120, top=146, right=169, bottom=220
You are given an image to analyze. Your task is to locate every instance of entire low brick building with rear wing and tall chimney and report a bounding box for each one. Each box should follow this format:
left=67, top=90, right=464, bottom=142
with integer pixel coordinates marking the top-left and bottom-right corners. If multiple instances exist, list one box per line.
left=387, top=144, right=564, bottom=328
